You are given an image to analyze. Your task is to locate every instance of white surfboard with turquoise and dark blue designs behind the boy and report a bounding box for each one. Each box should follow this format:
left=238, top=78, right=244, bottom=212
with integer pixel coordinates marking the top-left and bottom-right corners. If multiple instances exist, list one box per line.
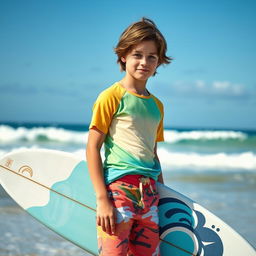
left=0, top=149, right=256, bottom=256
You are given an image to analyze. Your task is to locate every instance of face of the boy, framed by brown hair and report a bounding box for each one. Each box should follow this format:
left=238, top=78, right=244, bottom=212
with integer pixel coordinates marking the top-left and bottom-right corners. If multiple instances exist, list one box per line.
left=121, top=41, right=159, bottom=81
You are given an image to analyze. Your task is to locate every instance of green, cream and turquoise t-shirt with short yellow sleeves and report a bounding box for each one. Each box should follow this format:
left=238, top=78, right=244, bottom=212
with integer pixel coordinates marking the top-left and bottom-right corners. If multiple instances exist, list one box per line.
left=90, top=82, right=164, bottom=184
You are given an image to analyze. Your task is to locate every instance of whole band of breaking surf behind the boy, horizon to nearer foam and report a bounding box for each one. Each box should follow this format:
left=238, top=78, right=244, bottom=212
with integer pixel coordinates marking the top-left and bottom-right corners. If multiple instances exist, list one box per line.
left=0, top=124, right=256, bottom=172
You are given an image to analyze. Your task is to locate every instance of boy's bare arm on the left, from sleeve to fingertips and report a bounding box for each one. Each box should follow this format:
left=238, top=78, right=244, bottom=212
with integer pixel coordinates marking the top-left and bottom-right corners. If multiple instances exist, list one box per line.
left=86, top=127, right=115, bottom=234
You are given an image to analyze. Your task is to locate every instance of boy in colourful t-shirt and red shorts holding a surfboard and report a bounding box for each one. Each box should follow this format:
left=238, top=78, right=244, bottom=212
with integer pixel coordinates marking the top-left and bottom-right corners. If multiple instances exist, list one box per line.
left=86, top=18, right=171, bottom=256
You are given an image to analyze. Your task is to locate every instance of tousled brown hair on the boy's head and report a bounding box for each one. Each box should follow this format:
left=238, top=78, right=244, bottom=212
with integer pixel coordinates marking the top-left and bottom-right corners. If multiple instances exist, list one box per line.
left=115, top=17, right=172, bottom=71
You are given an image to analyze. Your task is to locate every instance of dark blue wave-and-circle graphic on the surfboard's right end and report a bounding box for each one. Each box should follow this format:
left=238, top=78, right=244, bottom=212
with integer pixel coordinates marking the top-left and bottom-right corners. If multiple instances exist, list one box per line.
left=159, top=197, right=223, bottom=256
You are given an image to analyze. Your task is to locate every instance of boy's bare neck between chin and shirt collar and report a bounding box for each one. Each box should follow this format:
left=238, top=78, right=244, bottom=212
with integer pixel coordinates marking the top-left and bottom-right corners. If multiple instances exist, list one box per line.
left=119, top=77, right=150, bottom=96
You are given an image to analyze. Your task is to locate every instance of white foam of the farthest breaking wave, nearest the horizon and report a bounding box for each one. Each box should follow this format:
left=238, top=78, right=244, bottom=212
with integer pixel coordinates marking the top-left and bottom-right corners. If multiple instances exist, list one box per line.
left=0, top=125, right=247, bottom=144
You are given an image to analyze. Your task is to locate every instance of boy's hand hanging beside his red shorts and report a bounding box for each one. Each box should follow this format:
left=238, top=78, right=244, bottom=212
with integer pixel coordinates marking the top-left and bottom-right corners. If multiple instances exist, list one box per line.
left=97, top=198, right=116, bottom=235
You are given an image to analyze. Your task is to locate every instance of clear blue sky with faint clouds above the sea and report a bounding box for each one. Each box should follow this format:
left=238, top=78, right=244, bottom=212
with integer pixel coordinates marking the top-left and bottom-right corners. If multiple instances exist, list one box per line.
left=0, top=0, right=256, bottom=129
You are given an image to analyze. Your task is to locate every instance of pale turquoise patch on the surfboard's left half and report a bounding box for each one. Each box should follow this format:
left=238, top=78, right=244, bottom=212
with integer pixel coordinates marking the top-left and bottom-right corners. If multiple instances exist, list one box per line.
left=27, top=161, right=97, bottom=254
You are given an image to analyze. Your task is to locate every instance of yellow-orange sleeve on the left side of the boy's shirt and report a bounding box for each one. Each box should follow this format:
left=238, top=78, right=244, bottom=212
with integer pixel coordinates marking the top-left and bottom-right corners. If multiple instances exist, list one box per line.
left=89, top=86, right=121, bottom=134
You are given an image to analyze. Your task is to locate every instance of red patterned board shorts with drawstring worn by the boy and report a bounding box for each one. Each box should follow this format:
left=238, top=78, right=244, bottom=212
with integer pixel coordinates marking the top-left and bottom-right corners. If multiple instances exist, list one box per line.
left=97, top=175, right=160, bottom=256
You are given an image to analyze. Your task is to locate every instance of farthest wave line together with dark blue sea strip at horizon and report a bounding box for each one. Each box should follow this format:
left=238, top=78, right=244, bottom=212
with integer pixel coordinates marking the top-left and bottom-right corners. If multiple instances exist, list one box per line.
left=0, top=124, right=256, bottom=146
